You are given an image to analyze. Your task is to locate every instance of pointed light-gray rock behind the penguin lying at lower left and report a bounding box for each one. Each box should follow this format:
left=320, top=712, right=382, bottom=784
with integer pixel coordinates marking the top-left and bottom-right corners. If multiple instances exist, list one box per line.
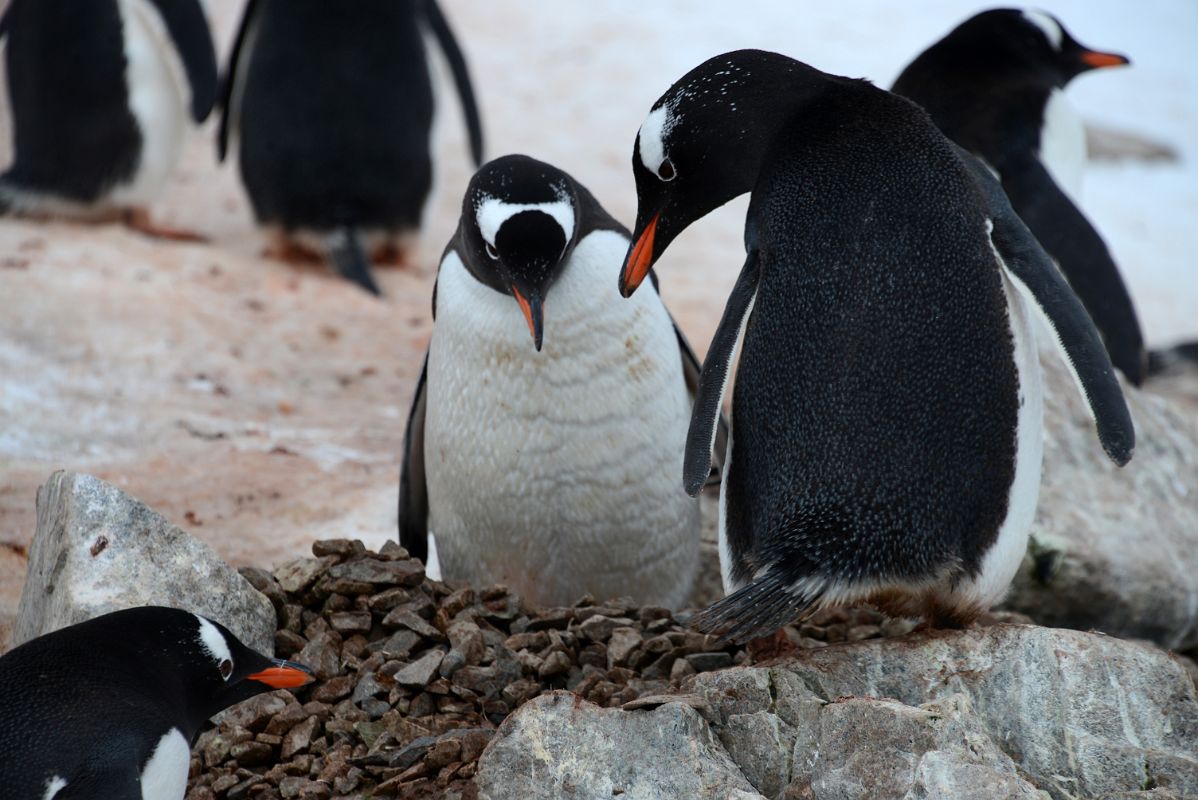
left=12, top=472, right=277, bottom=654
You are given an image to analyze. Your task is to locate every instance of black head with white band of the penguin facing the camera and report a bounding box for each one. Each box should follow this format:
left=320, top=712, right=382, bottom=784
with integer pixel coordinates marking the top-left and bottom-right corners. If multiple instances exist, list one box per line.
left=459, top=156, right=579, bottom=351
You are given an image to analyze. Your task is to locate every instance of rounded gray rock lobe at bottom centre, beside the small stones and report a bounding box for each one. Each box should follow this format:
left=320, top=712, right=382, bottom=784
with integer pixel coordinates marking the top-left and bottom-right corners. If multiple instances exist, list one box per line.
left=477, top=692, right=762, bottom=800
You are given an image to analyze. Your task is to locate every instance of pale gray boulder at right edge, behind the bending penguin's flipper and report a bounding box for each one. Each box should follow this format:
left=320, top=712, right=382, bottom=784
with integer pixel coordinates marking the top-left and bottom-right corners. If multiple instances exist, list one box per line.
left=1004, top=349, right=1198, bottom=650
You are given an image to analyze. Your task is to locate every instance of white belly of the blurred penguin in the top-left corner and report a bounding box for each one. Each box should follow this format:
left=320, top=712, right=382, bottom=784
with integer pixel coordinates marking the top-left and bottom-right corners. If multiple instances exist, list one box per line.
left=109, top=0, right=192, bottom=207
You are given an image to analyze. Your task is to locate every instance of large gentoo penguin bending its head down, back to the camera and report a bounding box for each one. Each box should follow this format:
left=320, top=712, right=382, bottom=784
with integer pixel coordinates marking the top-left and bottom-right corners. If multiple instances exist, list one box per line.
left=619, top=50, right=1135, bottom=641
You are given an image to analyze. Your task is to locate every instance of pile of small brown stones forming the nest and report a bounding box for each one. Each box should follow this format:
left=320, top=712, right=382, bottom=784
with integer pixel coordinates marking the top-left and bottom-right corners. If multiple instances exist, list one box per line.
left=187, top=539, right=910, bottom=800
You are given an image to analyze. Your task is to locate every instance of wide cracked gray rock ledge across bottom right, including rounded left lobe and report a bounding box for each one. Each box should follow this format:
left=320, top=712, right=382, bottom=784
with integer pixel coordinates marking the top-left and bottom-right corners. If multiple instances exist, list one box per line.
left=478, top=625, right=1198, bottom=800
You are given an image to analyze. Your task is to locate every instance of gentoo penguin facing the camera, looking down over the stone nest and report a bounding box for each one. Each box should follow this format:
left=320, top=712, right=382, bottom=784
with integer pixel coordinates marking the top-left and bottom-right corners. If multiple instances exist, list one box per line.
left=399, top=156, right=706, bottom=607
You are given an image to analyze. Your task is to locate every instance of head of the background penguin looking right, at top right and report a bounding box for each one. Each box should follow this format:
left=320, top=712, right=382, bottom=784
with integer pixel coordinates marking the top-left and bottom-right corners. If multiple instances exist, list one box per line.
left=943, top=8, right=1130, bottom=89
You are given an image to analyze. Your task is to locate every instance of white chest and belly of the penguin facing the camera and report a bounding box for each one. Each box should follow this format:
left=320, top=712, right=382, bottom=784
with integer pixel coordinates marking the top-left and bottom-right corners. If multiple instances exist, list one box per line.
left=424, top=231, right=698, bottom=606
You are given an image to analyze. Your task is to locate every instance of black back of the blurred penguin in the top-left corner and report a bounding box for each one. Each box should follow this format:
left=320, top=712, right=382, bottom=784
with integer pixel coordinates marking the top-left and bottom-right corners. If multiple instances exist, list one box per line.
left=4, top=0, right=141, bottom=202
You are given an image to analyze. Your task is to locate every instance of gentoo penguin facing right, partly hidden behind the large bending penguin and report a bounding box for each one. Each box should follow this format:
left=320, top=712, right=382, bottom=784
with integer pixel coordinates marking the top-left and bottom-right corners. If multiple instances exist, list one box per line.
left=893, top=8, right=1148, bottom=386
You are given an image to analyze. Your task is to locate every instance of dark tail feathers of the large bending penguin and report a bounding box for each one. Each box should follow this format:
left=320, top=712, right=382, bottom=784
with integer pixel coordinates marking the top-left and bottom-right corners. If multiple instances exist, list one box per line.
left=690, top=569, right=824, bottom=644
